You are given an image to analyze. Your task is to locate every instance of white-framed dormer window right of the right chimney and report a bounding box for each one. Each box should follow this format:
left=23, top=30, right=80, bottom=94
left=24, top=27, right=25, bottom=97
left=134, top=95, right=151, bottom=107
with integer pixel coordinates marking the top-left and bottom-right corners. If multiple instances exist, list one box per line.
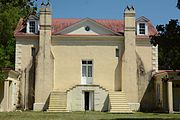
left=137, top=23, right=148, bottom=35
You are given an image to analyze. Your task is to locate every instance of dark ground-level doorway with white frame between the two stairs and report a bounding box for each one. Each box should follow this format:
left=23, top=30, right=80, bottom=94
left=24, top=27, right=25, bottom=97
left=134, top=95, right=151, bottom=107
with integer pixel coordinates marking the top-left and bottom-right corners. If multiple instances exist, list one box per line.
left=84, top=91, right=94, bottom=111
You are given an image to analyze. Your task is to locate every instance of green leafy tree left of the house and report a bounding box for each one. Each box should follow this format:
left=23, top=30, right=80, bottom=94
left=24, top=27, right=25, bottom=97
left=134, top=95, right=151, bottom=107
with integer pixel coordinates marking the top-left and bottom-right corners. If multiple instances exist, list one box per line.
left=0, top=0, right=37, bottom=79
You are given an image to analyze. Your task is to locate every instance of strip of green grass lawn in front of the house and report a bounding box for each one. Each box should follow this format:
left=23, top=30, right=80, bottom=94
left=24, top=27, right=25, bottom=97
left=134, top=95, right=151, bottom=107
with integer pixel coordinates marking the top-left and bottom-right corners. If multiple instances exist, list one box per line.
left=0, top=111, right=180, bottom=120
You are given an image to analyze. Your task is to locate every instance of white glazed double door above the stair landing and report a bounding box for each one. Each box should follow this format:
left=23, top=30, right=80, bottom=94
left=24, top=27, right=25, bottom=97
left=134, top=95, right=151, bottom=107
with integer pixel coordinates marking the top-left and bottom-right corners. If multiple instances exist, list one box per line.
left=81, top=60, right=93, bottom=84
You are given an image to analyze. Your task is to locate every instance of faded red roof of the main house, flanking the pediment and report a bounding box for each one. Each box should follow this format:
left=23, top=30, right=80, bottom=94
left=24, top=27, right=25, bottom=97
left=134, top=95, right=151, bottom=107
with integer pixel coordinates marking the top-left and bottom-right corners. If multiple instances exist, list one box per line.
left=14, top=18, right=157, bottom=36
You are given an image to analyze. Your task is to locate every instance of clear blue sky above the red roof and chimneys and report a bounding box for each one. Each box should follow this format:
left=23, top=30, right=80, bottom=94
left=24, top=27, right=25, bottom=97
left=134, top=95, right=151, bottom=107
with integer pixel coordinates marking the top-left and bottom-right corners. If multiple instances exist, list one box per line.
left=38, top=0, right=180, bottom=26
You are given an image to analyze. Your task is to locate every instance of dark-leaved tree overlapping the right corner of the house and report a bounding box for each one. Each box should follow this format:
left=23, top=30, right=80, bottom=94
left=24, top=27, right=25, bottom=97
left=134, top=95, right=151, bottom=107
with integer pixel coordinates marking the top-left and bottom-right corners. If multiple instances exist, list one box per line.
left=151, top=20, right=180, bottom=70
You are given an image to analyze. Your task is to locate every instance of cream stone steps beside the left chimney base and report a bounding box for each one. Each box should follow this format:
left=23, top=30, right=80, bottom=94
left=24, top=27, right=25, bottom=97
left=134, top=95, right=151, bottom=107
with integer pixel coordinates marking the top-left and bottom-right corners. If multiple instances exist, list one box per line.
left=47, top=91, right=67, bottom=112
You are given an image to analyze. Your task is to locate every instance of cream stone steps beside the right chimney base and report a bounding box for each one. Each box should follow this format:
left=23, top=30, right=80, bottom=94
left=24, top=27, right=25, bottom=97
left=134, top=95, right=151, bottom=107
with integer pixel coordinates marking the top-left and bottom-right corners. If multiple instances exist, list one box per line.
left=109, top=91, right=132, bottom=113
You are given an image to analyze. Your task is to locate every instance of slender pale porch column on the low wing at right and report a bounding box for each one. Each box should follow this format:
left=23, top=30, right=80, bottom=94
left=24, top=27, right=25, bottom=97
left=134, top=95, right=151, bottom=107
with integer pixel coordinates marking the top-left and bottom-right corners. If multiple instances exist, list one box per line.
left=168, top=80, right=173, bottom=113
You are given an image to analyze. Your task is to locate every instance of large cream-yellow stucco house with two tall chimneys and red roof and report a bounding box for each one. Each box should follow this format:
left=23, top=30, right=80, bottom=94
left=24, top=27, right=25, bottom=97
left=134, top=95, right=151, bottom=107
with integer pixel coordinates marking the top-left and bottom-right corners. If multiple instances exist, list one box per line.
left=14, top=5, right=158, bottom=113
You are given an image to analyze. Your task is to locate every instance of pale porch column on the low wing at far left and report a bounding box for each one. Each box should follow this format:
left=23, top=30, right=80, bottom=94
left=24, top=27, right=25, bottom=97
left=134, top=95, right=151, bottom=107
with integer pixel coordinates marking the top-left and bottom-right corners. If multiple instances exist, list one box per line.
left=3, top=80, right=9, bottom=111
